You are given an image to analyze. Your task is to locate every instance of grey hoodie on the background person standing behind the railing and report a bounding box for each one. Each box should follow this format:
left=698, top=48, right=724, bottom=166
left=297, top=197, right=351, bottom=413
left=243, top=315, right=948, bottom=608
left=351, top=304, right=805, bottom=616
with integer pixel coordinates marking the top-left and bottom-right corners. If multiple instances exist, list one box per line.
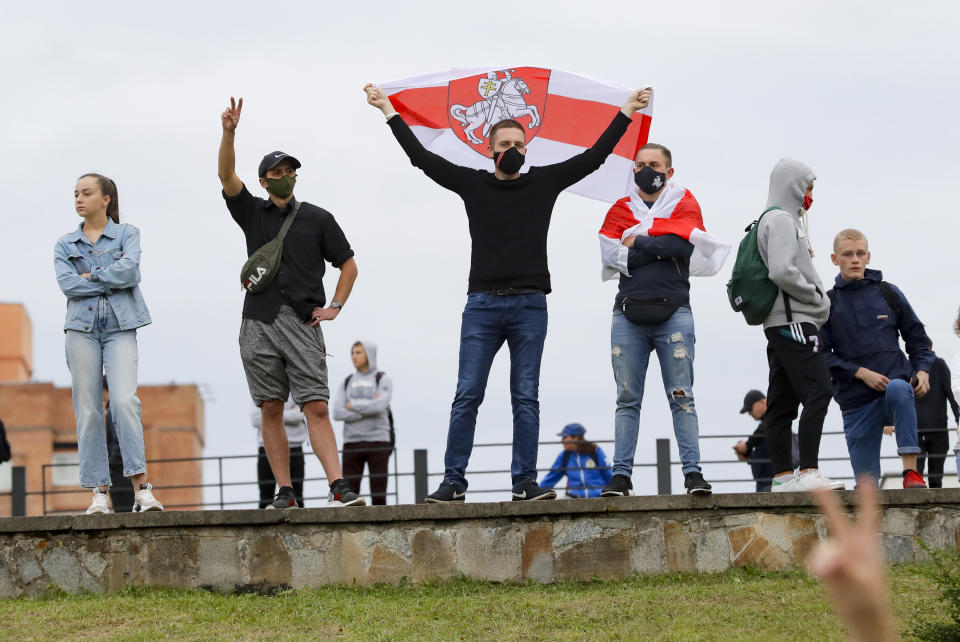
left=333, top=341, right=393, bottom=443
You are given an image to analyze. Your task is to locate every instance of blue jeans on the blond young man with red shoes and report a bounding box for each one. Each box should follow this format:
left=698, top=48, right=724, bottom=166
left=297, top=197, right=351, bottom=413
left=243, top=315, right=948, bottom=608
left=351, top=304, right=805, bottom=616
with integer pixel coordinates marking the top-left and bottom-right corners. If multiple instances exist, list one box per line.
left=843, top=379, right=920, bottom=480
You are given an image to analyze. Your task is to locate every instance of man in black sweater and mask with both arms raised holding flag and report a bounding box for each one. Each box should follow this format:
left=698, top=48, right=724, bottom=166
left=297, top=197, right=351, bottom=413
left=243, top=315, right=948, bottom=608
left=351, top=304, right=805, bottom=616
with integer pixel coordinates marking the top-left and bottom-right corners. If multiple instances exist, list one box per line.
left=364, top=78, right=651, bottom=503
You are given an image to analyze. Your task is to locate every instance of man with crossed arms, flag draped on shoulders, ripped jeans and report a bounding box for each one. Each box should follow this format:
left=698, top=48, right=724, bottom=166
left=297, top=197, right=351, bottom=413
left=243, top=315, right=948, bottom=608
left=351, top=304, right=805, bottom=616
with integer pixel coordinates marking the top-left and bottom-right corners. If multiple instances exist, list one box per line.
left=600, top=143, right=730, bottom=497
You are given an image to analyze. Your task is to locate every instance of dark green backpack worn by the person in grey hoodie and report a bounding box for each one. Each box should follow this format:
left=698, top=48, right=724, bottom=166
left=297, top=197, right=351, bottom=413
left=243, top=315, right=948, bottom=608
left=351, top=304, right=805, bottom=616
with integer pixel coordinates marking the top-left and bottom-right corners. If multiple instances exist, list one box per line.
left=727, top=207, right=780, bottom=325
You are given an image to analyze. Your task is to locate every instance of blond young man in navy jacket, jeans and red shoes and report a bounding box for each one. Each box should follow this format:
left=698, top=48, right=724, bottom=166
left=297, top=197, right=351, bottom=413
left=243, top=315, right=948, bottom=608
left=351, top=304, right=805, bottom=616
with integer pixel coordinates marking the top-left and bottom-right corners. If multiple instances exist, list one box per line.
left=820, top=229, right=935, bottom=488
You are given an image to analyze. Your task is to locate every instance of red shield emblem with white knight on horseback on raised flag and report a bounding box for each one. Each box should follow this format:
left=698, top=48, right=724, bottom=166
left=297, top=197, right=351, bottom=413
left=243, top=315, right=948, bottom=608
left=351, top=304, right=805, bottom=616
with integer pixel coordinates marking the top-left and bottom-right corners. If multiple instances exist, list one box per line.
left=447, top=67, right=550, bottom=156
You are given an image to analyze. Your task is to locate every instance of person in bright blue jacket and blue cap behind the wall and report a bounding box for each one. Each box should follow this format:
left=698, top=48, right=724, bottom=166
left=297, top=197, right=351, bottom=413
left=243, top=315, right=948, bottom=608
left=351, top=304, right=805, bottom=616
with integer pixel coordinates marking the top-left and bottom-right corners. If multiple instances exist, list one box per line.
left=540, top=424, right=613, bottom=498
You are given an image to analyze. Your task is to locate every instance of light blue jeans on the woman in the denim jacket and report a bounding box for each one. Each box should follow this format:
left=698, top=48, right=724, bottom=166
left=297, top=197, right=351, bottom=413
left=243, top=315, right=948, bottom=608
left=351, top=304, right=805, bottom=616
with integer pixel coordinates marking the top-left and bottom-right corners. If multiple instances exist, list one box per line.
left=66, top=297, right=147, bottom=488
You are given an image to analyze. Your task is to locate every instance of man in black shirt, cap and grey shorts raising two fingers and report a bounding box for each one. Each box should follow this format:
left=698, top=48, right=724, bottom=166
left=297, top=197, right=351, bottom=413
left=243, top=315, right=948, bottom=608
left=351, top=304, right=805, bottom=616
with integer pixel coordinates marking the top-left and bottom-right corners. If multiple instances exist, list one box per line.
left=218, top=98, right=365, bottom=508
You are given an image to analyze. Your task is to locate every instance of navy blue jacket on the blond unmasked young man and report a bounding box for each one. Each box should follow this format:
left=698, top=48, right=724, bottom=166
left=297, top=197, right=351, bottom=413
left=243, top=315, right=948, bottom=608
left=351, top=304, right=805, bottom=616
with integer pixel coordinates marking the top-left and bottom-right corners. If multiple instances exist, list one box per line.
left=820, top=269, right=936, bottom=410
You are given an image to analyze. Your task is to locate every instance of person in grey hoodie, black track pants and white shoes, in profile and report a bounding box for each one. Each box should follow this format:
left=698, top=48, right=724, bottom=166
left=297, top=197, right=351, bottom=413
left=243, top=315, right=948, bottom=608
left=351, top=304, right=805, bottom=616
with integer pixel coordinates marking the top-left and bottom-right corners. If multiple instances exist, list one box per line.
left=757, top=158, right=843, bottom=493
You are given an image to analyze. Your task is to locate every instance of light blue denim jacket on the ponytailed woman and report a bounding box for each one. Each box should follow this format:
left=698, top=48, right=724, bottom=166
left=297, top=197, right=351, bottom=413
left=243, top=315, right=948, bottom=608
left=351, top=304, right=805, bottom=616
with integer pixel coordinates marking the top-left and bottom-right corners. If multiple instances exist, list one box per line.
left=53, top=219, right=150, bottom=332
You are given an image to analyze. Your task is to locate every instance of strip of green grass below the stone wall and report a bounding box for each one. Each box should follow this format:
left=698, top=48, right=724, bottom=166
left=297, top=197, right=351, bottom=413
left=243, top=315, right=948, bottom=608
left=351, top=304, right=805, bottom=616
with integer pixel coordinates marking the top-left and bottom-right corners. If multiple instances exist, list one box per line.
left=0, top=567, right=942, bottom=642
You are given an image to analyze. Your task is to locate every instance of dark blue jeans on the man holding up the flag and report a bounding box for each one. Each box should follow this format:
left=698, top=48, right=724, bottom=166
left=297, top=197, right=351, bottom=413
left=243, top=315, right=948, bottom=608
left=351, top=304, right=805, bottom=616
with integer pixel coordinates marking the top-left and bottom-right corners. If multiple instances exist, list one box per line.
left=443, top=292, right=547, bottom=488
